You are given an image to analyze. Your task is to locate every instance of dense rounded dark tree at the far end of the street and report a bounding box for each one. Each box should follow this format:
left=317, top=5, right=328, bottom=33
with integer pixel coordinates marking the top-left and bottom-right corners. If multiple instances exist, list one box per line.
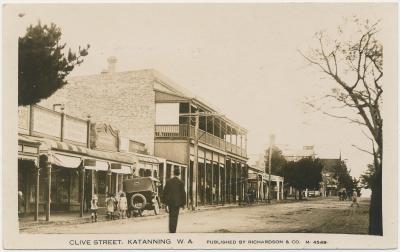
left=284, top=158, right=323, bottom=199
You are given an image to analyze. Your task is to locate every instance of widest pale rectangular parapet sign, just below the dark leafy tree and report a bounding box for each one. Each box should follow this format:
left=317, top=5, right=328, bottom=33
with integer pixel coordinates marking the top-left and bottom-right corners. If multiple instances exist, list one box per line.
left=32, top=107, right=61, bottom=137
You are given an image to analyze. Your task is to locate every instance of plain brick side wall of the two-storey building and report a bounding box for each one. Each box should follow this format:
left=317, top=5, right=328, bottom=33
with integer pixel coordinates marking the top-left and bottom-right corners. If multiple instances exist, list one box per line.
left=39, top=70, right=155, bottom=154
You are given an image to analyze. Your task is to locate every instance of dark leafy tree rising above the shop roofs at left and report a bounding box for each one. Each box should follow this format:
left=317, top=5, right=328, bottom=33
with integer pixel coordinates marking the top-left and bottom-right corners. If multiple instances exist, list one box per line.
left=18, top=22, right=90, bottom=106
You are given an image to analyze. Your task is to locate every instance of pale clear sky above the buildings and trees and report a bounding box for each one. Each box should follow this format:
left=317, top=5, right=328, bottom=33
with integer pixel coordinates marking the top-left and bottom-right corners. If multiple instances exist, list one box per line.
left=9, top=3, right=394, bottom=177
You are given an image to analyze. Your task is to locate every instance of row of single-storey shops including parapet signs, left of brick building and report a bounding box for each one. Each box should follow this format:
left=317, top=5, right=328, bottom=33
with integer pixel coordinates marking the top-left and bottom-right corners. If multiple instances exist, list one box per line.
left=18, top=106, right=186, bottom=220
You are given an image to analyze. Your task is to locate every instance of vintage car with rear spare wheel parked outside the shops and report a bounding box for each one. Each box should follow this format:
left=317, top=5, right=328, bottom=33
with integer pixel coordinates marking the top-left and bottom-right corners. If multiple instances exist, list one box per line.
left=124, top=177, right=160, bottom=217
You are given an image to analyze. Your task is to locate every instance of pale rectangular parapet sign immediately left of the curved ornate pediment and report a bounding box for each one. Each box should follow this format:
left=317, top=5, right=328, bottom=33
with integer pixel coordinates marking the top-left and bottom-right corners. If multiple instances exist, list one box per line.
left=64, top=116, right=87, bottom=144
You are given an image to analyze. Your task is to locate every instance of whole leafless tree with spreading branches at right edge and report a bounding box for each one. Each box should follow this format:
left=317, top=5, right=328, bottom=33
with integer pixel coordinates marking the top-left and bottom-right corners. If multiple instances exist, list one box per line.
left=299, top=17, right=383, bottom=235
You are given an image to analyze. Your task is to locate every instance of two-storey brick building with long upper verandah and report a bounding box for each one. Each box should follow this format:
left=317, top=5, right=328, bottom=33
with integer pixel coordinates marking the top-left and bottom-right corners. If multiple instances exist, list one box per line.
left=40, top=62, right=247, bottom=205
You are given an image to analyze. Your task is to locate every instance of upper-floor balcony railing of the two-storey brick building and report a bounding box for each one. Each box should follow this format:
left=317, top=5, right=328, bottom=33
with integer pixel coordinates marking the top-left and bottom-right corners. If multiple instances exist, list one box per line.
left=155, top=124, right=247, bottom=157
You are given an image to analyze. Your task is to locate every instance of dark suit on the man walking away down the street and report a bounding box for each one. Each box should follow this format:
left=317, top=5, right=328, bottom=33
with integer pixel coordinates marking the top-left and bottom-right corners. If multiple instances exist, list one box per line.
left=163, top=177, right=186, bottom=233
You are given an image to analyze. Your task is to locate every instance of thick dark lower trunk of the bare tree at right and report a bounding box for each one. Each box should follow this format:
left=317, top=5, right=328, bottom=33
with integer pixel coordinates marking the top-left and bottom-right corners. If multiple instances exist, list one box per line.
left=368, top=165, right=383, bottom=236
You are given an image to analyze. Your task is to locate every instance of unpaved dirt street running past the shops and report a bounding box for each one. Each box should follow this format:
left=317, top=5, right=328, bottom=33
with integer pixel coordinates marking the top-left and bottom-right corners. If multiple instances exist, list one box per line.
left=21, top=198, right=369, bottom=234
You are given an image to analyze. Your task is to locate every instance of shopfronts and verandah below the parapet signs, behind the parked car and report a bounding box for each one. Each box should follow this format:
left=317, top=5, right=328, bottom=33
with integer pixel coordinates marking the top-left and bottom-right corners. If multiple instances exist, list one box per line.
left=18, top=135, right=192, bottom=220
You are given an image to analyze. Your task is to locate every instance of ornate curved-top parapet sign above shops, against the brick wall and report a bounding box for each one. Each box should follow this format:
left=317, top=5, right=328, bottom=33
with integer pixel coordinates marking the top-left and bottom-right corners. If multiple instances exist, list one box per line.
left=90, top=124, right=119, bottom=151
